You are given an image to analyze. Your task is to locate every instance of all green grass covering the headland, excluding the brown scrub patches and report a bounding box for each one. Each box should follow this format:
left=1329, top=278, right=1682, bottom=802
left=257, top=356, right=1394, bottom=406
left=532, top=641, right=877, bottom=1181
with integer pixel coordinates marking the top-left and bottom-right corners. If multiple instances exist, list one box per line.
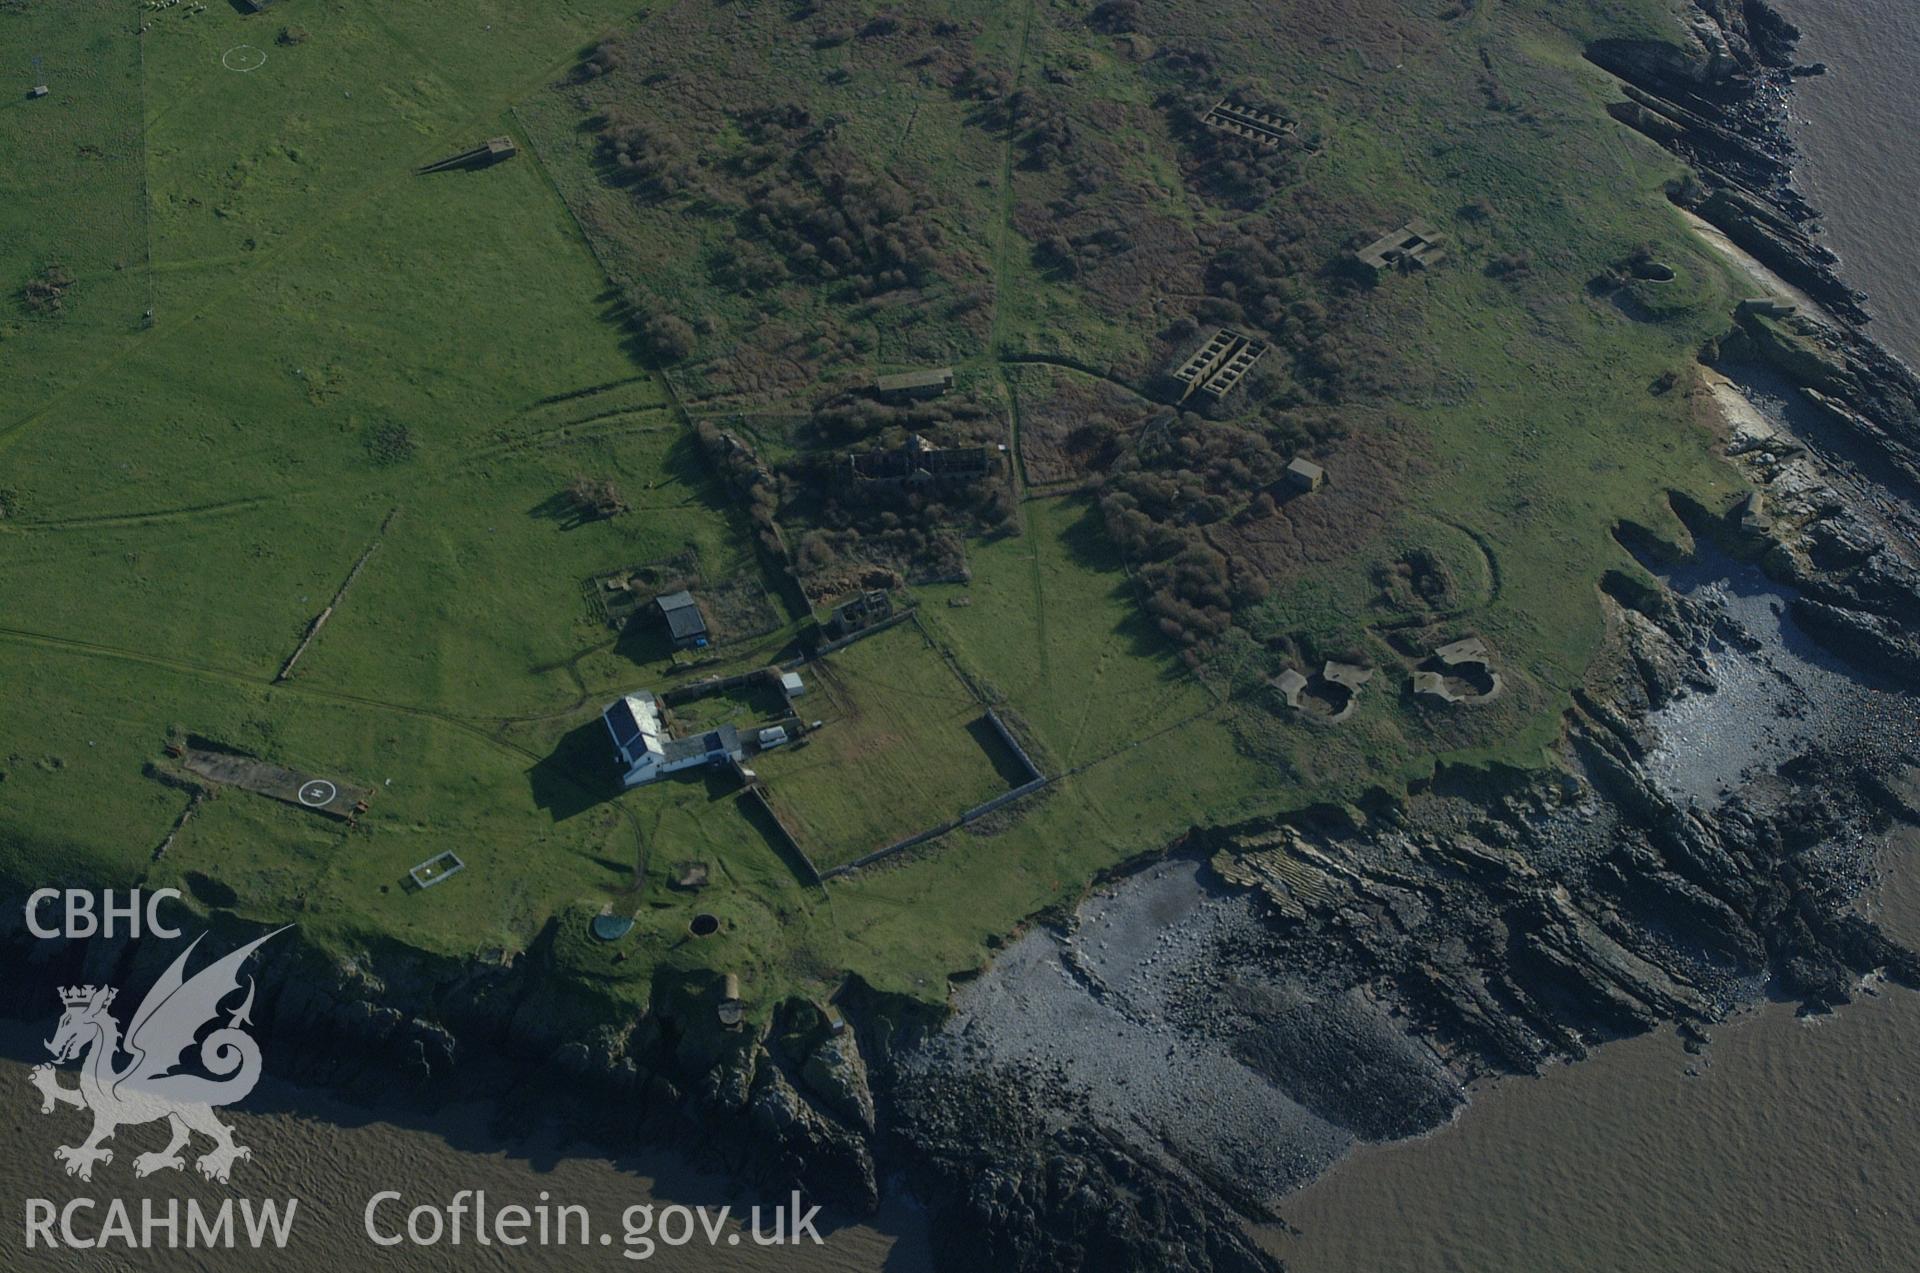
left=0, top=0, right=1766, bottom=1012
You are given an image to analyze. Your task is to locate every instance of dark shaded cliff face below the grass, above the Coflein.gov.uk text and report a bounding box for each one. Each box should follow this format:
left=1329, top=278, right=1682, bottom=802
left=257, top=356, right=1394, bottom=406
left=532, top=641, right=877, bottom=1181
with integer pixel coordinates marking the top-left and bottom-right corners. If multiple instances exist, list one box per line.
left=0, top=902, right=887, bottom=1213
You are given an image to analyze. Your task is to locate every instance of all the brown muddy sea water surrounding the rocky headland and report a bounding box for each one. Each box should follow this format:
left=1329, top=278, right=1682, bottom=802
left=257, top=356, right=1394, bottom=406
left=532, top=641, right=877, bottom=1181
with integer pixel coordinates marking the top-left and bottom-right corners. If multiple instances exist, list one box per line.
left=0, top=0, right=1920, bottom=1273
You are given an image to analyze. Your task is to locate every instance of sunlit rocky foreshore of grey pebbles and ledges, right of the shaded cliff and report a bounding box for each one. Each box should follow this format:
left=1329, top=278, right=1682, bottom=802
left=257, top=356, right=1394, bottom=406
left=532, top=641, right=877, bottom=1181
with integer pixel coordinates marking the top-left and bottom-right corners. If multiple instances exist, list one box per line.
left=893, top=0, right=1920, bottom=1269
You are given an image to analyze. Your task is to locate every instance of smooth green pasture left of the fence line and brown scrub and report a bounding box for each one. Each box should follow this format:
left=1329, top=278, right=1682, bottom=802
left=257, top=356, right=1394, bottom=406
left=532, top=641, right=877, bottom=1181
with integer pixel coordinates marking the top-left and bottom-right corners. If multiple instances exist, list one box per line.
left=0, top=4, right=714, bottom=979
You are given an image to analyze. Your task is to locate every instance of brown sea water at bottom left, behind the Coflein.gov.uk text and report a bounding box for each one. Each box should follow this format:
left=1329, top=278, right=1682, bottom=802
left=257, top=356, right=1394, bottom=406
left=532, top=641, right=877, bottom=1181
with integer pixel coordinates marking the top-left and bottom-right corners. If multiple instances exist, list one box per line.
left=0, top=1021, right=929, bottom=1273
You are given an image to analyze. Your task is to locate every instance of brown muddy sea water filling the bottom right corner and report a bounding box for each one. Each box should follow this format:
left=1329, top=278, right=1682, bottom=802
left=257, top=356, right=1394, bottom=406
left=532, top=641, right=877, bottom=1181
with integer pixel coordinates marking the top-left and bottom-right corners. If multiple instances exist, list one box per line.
left=1261, top=835, right=1920, bottom=1273
